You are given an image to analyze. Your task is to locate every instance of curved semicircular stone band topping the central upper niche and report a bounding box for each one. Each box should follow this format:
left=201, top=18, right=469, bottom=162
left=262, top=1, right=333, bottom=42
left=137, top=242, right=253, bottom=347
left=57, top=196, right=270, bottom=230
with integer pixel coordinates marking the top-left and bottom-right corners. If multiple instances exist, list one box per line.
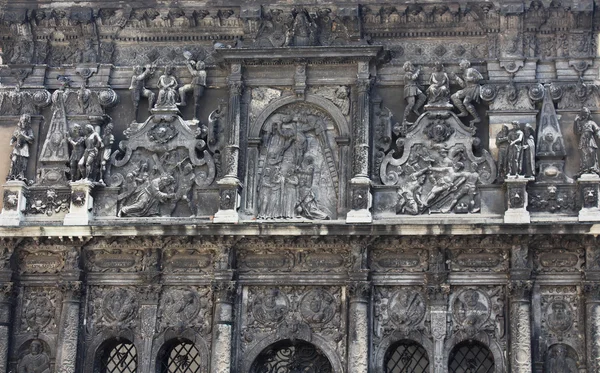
left=248, top=94, right=351, bottom=138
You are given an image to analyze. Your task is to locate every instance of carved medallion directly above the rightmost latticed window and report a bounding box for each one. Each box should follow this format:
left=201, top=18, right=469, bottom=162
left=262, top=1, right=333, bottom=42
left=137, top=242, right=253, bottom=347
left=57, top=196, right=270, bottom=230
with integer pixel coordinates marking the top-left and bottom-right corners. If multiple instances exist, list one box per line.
left=453, top=289, right=490, bottom=335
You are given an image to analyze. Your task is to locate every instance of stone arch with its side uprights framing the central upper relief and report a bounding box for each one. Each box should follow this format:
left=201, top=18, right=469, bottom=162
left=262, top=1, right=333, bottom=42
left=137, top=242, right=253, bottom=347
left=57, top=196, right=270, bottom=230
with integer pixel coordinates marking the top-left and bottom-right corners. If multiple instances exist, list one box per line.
left=242, top=94, right=351, bottom=216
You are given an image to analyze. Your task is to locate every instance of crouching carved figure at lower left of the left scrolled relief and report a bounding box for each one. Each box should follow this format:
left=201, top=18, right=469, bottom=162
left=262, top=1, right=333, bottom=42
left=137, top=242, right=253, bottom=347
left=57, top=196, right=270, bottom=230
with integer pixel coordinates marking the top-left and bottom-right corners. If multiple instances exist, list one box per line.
left=118, top=175, right=175, bottom=217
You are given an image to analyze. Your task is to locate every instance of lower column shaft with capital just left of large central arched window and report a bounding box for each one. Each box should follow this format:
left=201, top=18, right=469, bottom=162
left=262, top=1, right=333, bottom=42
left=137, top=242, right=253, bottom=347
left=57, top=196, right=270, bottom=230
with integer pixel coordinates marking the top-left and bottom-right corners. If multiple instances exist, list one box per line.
left=210, top=281, right=235, bottom=373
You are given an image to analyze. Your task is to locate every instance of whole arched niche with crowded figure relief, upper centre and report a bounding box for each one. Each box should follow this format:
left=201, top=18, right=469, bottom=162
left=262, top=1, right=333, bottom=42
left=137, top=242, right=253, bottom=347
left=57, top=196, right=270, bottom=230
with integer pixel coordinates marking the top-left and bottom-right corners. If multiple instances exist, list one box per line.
left=243, top=94, right=350, bottom=220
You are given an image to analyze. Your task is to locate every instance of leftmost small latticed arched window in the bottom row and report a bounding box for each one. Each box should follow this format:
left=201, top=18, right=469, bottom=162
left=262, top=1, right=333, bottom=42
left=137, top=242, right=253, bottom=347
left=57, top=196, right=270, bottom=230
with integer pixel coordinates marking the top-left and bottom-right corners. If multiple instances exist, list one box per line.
left=96, top=340, right=137, bottom=373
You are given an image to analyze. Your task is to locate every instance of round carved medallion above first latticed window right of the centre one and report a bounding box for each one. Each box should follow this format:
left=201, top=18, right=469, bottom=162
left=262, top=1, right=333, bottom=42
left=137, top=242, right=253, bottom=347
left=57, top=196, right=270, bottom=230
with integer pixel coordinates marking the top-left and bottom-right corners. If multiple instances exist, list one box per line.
left=389, top=289, right=426, bottom=329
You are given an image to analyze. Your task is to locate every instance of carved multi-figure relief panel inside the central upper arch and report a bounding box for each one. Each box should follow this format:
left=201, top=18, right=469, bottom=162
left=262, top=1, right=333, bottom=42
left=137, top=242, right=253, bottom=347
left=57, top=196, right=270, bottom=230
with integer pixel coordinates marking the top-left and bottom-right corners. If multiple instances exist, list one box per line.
left=257, top=105, right=337, bottom=219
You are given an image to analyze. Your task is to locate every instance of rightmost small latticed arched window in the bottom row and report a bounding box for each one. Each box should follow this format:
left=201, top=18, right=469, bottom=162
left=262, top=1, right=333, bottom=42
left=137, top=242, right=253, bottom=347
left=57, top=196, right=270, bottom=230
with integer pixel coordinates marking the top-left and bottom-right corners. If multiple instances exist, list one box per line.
left=448, top=341, right=495, bottom=373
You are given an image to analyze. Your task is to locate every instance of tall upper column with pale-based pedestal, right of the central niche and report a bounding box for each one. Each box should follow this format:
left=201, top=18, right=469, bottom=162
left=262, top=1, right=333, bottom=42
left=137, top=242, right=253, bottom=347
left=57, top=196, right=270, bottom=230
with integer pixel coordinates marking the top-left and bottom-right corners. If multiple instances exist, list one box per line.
left=346, top=61, right=373, bottom=223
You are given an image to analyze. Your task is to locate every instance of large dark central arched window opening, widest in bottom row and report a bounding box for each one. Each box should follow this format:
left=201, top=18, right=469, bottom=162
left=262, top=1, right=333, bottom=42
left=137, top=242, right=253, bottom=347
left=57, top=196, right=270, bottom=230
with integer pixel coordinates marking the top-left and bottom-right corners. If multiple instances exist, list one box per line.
left=250, top=340, right=333, bottom=373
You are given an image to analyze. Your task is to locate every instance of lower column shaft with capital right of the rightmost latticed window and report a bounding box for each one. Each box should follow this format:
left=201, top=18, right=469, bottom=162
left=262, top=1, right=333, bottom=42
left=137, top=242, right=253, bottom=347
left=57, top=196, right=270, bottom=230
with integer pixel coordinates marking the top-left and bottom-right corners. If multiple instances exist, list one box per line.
left=509, top=281, right=532, bottom=373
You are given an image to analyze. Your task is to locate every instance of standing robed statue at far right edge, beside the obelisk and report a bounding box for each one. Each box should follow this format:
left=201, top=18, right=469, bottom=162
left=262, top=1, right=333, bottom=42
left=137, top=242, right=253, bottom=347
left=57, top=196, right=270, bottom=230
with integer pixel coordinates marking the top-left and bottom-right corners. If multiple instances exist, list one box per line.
left=575, top=107, right=600, bottom=174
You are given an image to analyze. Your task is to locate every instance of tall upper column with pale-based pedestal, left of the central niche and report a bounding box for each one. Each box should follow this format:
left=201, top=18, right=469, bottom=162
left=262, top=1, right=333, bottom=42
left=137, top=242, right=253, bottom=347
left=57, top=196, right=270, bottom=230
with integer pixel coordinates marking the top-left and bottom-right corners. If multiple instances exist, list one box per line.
left=213, top=63, right=244, bottom=223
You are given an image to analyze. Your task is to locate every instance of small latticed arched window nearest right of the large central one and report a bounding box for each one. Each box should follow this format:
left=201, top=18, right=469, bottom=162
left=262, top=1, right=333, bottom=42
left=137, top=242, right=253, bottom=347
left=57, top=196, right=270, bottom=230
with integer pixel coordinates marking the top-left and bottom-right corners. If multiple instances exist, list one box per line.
left=385, top=341, right=429, bottom=373
